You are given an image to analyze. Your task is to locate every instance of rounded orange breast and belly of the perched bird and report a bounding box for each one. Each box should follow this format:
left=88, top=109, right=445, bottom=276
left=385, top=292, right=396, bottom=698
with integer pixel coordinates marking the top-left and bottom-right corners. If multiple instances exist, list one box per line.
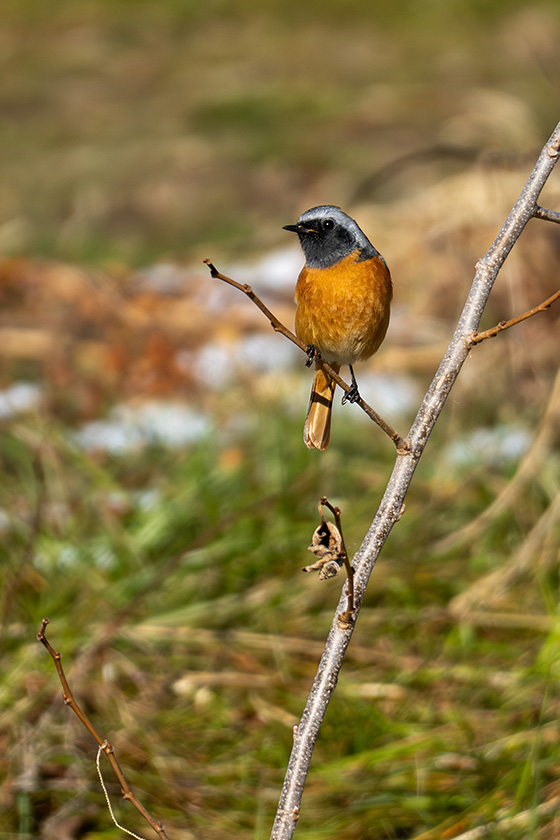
left=295, top=253, right=393, bottom=365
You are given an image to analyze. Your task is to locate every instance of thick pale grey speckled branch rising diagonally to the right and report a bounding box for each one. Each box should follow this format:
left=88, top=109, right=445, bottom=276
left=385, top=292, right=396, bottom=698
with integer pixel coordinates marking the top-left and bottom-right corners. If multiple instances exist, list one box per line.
left=271, top=123, right=560, bottom=840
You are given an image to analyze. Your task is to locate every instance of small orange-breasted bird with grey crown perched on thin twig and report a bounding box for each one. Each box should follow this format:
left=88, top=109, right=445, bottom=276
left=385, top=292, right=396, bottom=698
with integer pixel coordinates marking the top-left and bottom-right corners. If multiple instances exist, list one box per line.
left=283, top=204, right=393, bottom=450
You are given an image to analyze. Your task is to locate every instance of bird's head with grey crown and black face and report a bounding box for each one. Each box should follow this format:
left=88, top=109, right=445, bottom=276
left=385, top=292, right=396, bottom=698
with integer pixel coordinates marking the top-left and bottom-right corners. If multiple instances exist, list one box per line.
left=284, top=207, right=376, bottom=268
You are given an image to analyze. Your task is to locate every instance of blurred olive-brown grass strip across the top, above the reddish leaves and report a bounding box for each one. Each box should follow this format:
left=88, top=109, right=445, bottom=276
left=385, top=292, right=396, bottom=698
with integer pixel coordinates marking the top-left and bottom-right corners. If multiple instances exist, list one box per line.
left=0, top=0, right=560, bottom=265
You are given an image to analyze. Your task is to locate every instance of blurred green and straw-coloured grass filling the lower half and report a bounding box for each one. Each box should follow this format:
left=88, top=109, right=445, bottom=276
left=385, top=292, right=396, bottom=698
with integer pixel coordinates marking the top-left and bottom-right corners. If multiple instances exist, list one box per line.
left=0, top=390, right=559, bottom=838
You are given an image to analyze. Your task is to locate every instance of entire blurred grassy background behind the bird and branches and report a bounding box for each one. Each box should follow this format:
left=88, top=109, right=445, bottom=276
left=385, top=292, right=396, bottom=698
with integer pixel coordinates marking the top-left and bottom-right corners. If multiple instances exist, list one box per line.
left=0, top=0, right=560, bottom=840
